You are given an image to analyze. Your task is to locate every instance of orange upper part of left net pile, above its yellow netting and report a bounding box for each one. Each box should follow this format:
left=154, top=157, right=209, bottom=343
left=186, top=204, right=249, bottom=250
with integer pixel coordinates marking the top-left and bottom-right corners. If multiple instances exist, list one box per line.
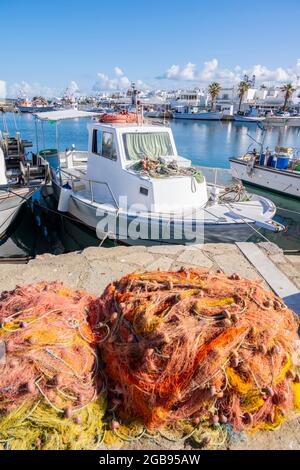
left=0, top=283, right=97, bottom=413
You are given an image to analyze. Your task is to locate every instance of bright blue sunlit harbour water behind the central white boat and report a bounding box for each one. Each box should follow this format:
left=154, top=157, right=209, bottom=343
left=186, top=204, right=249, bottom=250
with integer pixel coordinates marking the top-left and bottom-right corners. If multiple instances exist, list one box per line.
left=0, top=113, right=300, bottom=168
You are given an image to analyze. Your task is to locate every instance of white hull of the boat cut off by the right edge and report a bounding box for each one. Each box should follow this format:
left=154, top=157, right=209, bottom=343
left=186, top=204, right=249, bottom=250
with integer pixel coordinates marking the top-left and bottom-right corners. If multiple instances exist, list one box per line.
left=230, top=158, right=300, bottom=198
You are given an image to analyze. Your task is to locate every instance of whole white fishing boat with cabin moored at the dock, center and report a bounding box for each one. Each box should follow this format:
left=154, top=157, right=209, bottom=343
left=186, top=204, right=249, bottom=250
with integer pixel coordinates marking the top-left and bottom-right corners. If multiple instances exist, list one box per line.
left=34, top=112, right=284, bottom=245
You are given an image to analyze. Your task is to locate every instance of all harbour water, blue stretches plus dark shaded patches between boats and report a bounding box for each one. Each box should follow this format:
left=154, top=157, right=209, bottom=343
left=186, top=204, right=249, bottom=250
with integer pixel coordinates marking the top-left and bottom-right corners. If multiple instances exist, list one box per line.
left=0, top=113, right=300, bottom=257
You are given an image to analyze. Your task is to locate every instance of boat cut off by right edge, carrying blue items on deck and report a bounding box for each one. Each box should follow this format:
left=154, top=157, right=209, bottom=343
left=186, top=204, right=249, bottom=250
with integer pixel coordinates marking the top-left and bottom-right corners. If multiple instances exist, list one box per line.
left=229, top=146, right=300, bottom=199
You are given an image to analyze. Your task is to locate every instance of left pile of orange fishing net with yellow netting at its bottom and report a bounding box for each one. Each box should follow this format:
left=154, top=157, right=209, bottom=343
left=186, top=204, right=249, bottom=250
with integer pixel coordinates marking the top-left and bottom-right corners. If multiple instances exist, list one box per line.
left=0, top=283, right=106, bottom=449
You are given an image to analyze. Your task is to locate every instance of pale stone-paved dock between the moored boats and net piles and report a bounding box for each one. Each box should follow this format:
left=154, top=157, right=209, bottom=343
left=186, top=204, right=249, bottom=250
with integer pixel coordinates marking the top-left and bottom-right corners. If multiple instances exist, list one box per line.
left=0, top=243, right=300, bottom=450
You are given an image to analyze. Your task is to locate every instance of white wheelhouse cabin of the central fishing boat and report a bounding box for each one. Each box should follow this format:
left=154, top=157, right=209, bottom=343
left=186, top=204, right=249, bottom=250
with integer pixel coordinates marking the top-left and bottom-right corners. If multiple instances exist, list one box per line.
left=77, top=121, right=207, bottom=212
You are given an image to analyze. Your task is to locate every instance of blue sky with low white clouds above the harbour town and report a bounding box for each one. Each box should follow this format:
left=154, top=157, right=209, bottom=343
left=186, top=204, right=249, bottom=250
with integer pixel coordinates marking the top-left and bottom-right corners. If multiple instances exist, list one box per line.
left=0, top=0, right=300, bottom=97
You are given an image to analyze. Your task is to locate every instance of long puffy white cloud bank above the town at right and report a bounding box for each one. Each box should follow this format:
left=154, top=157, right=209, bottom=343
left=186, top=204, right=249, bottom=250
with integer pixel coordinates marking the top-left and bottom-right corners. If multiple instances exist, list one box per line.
left=157, top=58, right=300, bottom=84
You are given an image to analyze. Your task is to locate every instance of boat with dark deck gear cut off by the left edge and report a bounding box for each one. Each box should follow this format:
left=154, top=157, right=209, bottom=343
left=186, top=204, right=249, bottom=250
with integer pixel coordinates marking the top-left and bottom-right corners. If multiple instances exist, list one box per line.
left=0, top=131, right=49, bottom=243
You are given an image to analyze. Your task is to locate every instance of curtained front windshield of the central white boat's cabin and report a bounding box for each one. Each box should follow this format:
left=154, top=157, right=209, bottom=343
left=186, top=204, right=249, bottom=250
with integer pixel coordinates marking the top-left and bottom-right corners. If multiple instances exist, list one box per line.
left=123, top=132, right=174, bottom=161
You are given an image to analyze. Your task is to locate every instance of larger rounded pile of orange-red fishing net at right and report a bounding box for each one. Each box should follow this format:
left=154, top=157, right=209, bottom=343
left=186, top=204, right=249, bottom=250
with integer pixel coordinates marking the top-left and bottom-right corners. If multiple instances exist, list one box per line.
left=90, top=269, right=300, bottom=442
